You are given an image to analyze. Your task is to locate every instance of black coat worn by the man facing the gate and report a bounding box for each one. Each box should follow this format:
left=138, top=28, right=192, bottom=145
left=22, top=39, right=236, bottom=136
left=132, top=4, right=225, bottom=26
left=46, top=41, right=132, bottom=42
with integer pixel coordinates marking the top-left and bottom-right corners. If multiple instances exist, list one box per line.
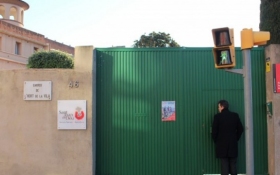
left=212, top=109, right=243, bottom=158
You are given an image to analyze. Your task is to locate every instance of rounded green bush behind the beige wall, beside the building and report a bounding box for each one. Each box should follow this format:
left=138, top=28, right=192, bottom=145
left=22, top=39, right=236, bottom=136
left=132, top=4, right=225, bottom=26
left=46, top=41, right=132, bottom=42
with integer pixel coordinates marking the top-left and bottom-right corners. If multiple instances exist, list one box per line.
left=27, top=51, right=74, bottom=69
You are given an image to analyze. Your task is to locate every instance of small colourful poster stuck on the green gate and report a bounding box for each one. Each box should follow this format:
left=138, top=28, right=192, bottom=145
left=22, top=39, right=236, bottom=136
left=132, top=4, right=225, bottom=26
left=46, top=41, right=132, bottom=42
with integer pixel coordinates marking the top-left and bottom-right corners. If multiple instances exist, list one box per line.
left=161, top=101, right=176, bottom=121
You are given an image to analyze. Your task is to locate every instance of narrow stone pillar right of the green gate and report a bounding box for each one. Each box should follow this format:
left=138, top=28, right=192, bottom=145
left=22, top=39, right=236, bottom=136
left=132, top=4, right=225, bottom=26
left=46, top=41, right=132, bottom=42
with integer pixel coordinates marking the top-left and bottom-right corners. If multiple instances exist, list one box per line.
left=265, top=44, right=280, bottom=175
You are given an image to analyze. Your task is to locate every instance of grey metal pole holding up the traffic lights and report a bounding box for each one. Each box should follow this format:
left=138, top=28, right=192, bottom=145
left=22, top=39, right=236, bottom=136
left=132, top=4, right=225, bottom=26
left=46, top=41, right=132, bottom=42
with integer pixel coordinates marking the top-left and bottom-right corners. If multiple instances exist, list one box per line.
left=242, top=49, right=254, bottom=175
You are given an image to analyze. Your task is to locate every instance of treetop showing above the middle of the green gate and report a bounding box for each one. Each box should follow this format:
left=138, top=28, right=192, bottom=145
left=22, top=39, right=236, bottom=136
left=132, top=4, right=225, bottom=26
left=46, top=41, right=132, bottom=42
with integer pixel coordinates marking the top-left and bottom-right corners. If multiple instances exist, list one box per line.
left=133, top=32, right=180, bottom=48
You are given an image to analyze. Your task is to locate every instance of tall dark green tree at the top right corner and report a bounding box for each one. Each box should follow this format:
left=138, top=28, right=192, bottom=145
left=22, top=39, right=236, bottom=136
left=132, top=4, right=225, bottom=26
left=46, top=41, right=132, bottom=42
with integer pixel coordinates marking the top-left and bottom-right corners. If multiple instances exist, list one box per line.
left=259, top=0, right=280, bottom=44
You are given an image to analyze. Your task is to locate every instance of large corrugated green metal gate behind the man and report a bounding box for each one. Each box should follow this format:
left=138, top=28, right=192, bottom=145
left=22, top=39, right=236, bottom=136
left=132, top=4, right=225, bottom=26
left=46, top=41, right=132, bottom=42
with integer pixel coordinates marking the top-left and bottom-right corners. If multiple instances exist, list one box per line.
left=96, top=48, right=268, bottom=175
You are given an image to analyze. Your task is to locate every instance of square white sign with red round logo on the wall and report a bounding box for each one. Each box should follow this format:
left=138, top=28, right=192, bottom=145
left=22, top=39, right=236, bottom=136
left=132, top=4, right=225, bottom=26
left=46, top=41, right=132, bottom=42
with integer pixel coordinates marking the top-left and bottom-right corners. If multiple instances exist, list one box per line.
left=57, top=100, right=87, bottom=129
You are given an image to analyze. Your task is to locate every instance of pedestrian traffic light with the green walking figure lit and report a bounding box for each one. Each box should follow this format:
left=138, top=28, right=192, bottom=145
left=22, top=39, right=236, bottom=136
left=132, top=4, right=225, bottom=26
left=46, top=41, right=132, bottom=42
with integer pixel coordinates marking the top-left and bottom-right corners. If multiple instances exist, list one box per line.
left=212, top=27, right=235, bottom=69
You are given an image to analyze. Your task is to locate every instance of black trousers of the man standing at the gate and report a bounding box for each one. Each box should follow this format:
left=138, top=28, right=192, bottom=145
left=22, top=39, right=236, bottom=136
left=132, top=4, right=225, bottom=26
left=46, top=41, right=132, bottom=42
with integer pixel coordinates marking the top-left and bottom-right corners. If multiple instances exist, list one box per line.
left=220, top=157, right=237, bottom=175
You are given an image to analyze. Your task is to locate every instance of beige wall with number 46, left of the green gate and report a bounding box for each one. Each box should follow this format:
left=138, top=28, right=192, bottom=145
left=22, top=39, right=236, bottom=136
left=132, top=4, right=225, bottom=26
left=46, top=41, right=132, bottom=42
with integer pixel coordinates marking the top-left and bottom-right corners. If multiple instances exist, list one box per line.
left=0, top=46, right=95, bottom=175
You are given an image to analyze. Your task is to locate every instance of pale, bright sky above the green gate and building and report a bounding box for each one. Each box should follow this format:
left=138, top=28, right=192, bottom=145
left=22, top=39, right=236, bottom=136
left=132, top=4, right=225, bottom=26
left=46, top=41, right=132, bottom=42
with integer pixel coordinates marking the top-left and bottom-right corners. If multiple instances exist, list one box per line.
left=23, top=0, right=260, bottom=48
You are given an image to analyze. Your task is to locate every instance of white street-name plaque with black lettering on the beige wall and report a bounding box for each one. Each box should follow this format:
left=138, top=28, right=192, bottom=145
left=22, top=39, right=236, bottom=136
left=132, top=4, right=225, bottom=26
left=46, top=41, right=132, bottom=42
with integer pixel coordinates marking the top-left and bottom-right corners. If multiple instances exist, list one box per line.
left=23, top=81, right=52, bottom=100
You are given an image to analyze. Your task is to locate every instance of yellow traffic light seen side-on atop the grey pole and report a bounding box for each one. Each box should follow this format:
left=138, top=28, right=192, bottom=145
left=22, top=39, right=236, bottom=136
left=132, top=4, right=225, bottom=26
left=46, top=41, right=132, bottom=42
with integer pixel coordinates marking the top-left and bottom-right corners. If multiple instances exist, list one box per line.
left=241, top=29, right=270, bottom=50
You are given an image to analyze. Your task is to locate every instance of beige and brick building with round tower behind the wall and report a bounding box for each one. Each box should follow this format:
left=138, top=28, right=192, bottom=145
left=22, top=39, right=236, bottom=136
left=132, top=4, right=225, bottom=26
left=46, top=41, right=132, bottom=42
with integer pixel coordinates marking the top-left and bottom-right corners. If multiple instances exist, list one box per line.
left=0, top=0, right=74, bottom=70
